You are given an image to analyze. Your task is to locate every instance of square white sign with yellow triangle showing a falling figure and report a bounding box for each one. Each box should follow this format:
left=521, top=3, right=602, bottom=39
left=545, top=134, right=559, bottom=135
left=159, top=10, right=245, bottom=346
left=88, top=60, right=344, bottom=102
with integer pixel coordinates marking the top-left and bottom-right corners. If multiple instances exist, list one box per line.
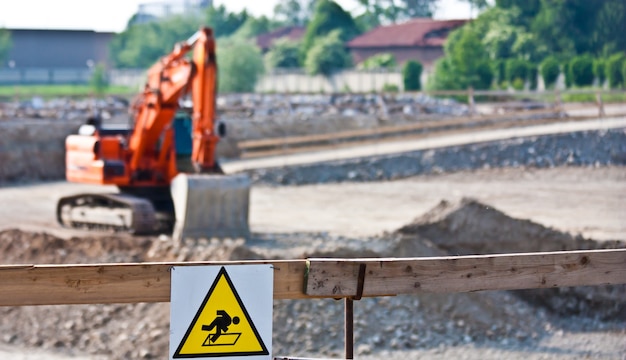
left=170, top=265, right=273, bottom=359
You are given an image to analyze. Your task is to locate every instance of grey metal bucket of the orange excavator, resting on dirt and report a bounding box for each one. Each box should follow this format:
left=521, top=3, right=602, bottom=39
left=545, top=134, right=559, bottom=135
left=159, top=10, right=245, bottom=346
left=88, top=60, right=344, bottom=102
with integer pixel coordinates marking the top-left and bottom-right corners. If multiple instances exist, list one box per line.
left=171, top=173, right=250, bottom=243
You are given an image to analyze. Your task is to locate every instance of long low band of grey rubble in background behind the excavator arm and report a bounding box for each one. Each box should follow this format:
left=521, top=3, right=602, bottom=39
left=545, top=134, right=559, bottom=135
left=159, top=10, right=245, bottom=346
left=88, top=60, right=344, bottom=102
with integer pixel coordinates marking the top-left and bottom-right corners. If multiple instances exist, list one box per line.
left=0, top=94, right=469, bottom=120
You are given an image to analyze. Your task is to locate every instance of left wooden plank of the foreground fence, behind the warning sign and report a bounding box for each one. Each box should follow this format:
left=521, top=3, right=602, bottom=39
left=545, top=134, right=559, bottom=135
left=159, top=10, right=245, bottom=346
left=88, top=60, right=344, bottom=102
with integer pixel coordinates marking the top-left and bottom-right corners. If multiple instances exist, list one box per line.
left=0, top=260, right=306, bottom=306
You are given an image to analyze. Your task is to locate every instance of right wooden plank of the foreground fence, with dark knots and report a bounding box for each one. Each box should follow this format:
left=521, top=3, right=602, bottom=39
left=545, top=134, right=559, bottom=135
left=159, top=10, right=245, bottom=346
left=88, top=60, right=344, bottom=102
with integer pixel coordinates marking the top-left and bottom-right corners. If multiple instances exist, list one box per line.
left=305, top=249, right=626, bottom=298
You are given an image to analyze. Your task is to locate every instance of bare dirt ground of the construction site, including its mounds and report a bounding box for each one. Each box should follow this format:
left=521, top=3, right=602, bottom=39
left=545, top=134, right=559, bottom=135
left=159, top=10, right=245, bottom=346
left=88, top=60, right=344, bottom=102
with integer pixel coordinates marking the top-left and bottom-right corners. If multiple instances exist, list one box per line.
left=0, top=111, right=626, bottom=360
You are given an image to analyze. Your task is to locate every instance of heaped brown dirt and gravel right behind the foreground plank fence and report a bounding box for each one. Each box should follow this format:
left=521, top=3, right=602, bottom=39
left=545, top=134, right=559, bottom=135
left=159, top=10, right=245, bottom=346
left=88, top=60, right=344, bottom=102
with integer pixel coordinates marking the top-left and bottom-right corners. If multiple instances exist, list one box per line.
left=0, top=200, right=626, bottom=359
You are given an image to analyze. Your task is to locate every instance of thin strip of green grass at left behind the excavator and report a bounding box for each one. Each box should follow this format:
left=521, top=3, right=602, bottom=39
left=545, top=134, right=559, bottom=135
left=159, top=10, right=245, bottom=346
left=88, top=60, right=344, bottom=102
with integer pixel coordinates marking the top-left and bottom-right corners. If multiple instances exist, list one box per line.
left=0, top=85, right=138, bottom=100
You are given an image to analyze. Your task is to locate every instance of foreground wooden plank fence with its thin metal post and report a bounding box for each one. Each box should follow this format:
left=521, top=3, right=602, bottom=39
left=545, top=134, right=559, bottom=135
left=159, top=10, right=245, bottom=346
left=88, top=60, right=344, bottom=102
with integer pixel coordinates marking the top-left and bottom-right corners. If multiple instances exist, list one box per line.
left=0, top=249, right=626, bottom=359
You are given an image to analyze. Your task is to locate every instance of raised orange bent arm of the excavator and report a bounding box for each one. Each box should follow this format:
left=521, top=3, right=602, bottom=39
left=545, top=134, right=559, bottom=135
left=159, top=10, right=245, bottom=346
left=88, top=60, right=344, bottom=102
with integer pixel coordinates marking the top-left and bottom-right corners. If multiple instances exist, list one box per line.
left=128, top=28, right=219, bottom=183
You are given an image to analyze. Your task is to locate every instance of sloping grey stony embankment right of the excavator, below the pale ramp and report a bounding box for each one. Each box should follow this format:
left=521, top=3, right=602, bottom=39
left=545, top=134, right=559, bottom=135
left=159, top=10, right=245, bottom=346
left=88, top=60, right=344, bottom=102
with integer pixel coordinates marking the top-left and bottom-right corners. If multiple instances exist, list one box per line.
left=247, top=129, right=626, bottom=185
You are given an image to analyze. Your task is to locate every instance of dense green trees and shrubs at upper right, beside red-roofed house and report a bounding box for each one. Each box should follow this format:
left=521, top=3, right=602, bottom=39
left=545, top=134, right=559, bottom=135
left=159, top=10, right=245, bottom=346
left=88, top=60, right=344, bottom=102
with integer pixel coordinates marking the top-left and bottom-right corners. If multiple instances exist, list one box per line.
left=429, top=0, right=626, bottom=89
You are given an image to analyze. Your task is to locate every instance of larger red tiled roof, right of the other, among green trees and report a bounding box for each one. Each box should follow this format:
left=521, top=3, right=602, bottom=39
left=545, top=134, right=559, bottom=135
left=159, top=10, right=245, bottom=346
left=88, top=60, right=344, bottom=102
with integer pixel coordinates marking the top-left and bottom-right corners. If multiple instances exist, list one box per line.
left=348, top=18, right=469, bottom=48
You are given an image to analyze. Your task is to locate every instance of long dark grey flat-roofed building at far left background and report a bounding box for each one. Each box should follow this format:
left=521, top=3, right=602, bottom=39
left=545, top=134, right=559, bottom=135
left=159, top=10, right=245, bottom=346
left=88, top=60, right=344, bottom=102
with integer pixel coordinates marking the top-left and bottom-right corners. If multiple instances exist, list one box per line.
left=7, top=29, right=115, bottom=69
